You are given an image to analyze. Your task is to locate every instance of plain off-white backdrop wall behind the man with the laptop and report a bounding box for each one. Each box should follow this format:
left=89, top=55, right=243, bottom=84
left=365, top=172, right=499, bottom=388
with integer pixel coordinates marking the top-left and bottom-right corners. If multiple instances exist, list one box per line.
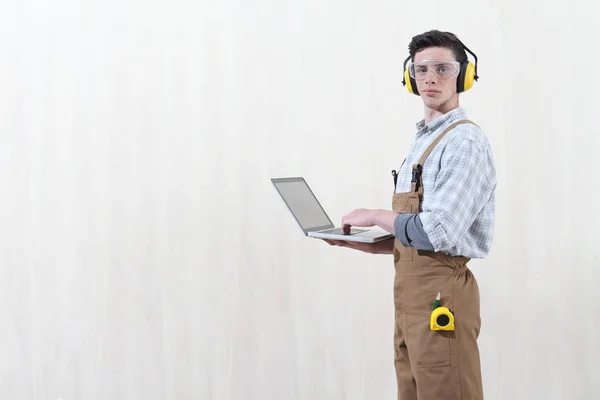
left=0, top=0, right=600, bottom=400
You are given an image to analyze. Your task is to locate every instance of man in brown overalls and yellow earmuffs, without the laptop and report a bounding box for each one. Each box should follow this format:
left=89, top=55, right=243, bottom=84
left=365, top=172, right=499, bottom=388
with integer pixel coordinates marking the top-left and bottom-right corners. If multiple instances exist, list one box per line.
left=327, top=30, right=496, bottom=400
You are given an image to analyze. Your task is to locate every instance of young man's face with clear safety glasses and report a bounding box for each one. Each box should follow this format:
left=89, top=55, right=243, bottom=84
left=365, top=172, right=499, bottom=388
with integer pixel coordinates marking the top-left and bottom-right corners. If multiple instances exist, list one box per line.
left=414, top=47, right=460, bottom=110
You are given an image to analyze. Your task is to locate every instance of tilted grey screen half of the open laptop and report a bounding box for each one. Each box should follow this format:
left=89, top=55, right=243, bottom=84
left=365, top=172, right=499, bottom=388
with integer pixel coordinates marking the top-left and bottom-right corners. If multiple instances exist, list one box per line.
left=272, top=178, right=333, bottom=232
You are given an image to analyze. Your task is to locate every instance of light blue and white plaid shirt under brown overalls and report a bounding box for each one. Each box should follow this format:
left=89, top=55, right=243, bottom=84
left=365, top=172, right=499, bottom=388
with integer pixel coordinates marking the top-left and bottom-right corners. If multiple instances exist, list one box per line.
left=396, top=107, right=496, bottom=258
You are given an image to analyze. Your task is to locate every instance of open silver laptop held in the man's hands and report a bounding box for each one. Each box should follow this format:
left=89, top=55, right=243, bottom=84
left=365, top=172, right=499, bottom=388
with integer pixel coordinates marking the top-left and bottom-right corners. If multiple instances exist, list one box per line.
left=271, top=177, right=394, bottom=243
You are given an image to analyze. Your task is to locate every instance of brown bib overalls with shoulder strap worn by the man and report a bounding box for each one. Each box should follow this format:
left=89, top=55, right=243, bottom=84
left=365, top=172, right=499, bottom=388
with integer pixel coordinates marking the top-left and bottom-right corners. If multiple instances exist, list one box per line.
left=392, top=120, right=483, bottom=400
